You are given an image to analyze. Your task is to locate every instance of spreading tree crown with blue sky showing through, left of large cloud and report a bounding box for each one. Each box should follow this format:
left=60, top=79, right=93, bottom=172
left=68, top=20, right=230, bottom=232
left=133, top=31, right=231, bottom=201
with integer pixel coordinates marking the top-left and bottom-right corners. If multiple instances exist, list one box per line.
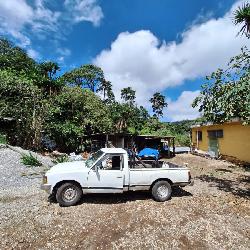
left=62, top=64, right=104, bottom=92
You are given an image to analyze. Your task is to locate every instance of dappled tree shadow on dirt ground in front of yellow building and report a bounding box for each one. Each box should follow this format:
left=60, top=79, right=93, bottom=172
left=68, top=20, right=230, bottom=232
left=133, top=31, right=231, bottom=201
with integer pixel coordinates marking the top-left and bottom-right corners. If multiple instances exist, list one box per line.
left=196, top=175, right=250, bottom=199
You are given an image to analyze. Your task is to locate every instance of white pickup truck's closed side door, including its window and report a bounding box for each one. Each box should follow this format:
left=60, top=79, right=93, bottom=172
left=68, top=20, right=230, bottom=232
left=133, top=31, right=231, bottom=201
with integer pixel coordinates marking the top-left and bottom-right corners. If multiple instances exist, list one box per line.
left=87, top=154, right=124, bottom=193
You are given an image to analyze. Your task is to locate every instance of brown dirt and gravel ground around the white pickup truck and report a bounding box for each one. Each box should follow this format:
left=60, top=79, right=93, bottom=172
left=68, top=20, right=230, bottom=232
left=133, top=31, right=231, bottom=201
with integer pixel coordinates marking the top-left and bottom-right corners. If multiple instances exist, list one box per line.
left=0, top=147, right=250, bottom=250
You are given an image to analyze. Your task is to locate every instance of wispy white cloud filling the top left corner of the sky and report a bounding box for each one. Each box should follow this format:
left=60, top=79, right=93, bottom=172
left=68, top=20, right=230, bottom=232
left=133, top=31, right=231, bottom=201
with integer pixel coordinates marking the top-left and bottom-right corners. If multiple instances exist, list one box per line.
left=0, top=0, right=60, bottom=47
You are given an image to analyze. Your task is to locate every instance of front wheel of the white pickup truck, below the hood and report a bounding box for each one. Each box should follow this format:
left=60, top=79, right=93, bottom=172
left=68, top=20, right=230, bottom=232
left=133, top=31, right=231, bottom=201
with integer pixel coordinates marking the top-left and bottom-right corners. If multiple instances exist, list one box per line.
left=56, top=182, right=82, bottom=207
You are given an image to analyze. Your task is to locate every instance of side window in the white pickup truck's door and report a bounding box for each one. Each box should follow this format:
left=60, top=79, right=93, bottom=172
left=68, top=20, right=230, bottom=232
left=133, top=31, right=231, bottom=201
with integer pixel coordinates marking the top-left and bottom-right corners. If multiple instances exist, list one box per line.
left=100, top=154, right=123, bottom=170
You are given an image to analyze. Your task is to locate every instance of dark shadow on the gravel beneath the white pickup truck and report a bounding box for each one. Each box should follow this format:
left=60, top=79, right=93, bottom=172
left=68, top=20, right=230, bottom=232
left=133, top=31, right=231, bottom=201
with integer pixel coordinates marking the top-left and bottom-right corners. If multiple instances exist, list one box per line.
left=48, top=187, right=193, bottom=204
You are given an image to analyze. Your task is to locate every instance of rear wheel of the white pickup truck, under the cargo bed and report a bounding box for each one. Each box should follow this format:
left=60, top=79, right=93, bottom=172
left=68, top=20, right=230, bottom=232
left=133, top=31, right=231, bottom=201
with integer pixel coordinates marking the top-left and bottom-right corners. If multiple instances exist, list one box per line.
left=151, top=181, right=172, bottom=201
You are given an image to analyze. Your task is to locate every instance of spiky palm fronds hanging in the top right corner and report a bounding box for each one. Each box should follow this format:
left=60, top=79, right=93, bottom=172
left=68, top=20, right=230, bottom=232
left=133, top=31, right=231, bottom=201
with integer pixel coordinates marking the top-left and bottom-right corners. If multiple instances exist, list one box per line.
left=234, top=3, right=250, bottom=38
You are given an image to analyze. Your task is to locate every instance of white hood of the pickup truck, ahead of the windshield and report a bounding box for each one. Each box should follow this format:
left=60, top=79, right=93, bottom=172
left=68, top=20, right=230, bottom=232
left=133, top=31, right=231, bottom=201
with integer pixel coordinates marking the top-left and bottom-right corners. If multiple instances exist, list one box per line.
left=47, top=161, right=88, bottom=174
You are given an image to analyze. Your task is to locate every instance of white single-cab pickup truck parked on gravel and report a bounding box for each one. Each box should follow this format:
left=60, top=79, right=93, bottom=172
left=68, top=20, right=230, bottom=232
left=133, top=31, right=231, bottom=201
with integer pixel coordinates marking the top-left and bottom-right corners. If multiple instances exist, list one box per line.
left=41, top=148, right=192, bottom=206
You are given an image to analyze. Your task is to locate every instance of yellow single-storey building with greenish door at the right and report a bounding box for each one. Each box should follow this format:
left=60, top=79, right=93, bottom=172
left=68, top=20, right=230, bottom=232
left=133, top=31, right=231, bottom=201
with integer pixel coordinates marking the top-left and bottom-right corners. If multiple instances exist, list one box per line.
left=192, top=121, right=250, bottom=163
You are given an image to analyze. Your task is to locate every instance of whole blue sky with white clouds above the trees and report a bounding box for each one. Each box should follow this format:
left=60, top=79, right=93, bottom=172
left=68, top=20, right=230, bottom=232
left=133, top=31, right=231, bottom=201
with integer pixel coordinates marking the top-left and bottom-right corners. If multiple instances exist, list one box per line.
left=0, top=0, right=248, bottom=121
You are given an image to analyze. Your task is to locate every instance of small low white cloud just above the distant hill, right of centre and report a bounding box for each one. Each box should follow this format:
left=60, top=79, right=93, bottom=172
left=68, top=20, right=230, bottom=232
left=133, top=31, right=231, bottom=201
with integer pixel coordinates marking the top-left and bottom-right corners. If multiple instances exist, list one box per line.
left=167, top=90, right=200, bottom=121
